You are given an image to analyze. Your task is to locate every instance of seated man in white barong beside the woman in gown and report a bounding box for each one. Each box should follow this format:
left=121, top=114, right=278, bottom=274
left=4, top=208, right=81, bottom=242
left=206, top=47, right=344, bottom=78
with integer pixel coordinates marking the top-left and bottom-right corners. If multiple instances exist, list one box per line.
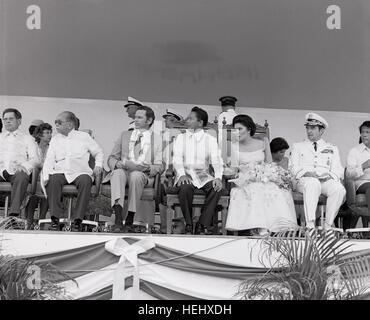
left=173, top=107, right=223, bottom=234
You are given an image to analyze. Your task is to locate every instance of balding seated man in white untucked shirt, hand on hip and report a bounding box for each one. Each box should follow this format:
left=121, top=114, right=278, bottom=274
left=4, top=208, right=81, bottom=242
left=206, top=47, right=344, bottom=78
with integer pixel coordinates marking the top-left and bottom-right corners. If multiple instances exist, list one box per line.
left=43, top=111, right=104, bottom=231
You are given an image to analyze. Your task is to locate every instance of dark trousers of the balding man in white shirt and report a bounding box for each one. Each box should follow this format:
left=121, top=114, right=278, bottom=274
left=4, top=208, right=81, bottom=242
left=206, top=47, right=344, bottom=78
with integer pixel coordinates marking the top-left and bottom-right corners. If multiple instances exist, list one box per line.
left=46, top=173, right=92, bottom=220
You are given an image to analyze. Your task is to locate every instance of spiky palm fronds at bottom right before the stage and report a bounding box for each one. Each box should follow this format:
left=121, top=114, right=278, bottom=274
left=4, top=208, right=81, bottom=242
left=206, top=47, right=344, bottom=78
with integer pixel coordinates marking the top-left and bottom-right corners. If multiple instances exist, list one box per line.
left=236, top=229, right=370, bottom=300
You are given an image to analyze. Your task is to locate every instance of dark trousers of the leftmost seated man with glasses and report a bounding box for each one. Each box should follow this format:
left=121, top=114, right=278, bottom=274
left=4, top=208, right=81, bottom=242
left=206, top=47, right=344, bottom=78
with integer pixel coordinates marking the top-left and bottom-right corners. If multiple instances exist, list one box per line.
left=0, top=171, right=30, bottom=216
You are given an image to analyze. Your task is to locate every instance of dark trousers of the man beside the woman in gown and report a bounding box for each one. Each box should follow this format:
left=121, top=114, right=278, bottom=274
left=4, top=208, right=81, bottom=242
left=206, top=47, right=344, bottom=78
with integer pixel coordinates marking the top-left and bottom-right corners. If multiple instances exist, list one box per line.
left=179, top=181, right=221, bottom=227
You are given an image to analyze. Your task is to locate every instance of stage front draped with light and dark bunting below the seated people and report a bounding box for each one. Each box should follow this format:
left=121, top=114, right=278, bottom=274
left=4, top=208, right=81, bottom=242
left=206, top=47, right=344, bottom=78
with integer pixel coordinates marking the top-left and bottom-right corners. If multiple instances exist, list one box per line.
left=0, top=230, right=370, bottom=299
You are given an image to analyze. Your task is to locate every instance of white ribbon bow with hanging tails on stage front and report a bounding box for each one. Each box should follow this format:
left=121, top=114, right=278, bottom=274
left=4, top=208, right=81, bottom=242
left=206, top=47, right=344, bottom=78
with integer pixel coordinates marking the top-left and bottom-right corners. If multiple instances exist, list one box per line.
left=105, top=236, right=155, bottom=300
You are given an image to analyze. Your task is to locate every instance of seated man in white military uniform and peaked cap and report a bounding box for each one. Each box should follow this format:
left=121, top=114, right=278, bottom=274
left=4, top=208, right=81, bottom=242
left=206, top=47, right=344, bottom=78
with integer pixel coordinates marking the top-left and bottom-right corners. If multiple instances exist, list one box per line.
left=290, top=112, right=346, bottom=229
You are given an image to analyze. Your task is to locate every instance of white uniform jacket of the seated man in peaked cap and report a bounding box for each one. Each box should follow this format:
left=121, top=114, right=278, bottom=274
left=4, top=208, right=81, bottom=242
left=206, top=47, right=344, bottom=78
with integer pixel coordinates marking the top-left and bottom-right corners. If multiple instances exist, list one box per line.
left=290, top=139, right=344, bottom=181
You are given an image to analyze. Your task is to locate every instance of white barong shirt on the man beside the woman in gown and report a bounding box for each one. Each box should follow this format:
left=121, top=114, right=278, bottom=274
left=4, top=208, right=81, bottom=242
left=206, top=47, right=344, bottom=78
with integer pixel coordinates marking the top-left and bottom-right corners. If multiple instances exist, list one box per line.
left=173, top=130, right=223, bottom=188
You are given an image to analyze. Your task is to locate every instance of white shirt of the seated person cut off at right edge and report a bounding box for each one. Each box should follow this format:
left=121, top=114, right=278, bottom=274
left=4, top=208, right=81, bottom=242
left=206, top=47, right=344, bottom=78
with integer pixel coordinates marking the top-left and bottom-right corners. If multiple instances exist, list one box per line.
left=347, top=143, right=370, bottom=189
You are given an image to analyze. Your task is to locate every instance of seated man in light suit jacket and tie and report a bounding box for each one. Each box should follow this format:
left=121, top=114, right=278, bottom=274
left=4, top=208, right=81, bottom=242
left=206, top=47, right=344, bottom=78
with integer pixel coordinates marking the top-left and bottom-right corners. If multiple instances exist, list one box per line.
left=103, top=106, right=164, bottom=232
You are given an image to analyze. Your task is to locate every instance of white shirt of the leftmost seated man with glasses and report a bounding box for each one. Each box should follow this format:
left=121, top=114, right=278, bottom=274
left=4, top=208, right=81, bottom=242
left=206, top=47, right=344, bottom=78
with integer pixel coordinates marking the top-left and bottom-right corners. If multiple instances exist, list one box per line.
left=0, top=130, right=39, bottom=176
